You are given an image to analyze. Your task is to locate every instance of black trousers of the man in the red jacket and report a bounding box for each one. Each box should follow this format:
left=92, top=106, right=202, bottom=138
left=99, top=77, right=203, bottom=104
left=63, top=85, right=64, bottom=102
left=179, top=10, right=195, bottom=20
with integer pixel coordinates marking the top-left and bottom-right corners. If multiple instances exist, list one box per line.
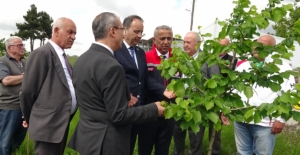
left=138, top=118, right=174, bottom=155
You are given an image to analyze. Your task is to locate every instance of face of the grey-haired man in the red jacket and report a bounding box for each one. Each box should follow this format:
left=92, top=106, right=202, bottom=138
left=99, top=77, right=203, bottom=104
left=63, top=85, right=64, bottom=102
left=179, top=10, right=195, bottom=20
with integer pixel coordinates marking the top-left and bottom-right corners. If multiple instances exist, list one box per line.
left=153, top=29, right=173, bottom=54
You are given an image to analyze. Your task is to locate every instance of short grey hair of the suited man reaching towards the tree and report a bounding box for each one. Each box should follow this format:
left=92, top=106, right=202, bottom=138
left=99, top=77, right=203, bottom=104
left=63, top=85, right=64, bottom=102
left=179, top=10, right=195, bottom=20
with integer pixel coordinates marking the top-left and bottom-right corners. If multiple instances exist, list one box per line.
left=92, top=12, right=119, bottom=41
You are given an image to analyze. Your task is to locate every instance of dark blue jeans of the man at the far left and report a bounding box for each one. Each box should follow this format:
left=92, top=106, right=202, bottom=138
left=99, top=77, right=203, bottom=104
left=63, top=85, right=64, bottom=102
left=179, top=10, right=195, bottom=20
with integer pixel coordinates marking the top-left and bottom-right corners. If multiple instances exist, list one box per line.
left=0, top=109, right=27, bottom=155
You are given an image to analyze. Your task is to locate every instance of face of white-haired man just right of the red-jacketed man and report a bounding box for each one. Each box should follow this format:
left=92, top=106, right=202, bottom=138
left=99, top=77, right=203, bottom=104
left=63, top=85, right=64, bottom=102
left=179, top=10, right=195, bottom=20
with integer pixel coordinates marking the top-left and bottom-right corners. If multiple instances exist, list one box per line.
left=183, top=33, right=198, bottom=56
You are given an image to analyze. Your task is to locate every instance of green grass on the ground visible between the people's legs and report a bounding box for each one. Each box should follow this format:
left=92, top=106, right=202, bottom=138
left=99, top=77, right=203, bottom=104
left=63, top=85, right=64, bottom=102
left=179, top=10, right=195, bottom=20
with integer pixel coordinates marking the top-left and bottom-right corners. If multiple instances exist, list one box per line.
left=14, top=109, right=300, bottom=155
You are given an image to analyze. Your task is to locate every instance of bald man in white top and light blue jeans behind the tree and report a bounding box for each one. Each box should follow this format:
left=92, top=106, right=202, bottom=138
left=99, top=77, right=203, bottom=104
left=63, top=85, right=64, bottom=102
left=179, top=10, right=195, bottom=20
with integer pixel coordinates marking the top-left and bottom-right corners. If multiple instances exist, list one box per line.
left=234, top=35, right=295, bottom=155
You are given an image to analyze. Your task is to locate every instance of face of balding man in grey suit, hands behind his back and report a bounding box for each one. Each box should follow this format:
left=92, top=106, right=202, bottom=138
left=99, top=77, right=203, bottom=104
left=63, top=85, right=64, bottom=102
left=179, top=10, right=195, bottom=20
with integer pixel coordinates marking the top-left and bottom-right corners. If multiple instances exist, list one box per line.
left=54, top=19, right=76, bottom=49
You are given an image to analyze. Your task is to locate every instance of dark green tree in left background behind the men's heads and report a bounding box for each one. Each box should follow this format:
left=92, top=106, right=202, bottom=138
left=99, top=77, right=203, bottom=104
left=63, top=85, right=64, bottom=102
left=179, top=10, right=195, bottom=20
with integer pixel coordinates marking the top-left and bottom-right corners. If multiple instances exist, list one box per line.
left=11, top=4, right=53, bottom=51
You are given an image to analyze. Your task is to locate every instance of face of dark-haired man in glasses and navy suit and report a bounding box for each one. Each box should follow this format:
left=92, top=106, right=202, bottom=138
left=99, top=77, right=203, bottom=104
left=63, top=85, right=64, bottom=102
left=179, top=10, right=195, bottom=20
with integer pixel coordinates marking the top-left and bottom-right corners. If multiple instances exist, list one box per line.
left=124, top=19, right=144, bottom=46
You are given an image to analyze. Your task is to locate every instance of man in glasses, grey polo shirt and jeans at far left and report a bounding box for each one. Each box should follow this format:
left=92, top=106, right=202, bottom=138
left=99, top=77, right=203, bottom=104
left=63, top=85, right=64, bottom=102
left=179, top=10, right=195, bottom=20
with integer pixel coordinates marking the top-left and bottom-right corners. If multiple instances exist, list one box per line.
left=0, top=36, right=27, bottom=155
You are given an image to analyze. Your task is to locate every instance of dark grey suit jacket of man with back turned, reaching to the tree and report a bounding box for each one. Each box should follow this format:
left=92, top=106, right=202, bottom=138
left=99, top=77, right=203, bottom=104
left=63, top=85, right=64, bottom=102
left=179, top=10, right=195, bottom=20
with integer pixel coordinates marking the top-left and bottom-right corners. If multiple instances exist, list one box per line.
left=68, top=44, right=158, bottom=155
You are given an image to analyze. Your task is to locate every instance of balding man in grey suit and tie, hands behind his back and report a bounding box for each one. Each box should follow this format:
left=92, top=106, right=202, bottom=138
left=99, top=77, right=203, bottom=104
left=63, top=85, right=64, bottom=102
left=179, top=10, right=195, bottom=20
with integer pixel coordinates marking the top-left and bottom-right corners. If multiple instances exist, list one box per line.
left=20, top=18, right=76, bottom=155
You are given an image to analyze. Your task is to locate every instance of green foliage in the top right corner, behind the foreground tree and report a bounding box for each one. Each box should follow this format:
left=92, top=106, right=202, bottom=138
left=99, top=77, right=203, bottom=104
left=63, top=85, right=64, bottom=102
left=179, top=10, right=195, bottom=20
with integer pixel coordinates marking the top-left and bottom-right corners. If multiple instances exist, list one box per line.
left=273, top=6, right=300, bottom=38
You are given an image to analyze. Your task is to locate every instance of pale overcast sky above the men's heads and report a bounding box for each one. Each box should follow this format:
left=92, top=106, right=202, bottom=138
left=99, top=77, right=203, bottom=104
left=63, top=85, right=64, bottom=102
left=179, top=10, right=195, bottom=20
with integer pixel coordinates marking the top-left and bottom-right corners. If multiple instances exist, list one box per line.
left=0, top=0, right=298, bottom=55
